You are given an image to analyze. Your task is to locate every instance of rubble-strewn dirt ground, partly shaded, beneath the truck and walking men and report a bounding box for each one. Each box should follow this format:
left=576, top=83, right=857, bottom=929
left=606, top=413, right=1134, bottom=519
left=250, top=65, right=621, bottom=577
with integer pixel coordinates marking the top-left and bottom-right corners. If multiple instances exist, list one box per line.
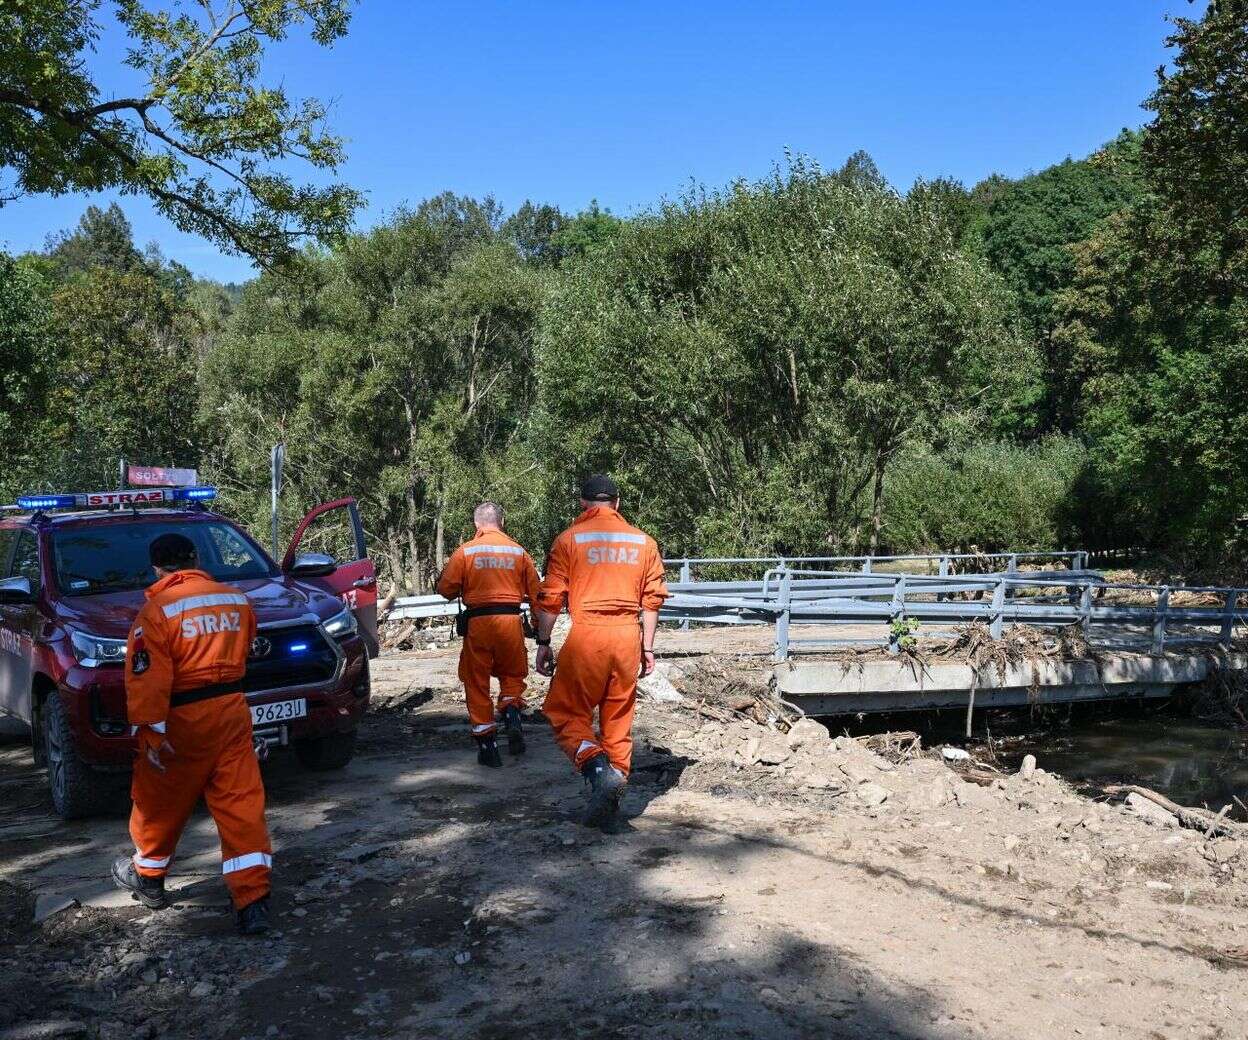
left=0, top=636, right=1248, bottom=1040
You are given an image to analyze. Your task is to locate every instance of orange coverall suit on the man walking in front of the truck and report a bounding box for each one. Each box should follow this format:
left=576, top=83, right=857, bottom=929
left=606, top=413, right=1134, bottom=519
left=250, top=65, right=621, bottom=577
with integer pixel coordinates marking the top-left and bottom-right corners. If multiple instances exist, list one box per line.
left=126, top=571, right=272, bottom=909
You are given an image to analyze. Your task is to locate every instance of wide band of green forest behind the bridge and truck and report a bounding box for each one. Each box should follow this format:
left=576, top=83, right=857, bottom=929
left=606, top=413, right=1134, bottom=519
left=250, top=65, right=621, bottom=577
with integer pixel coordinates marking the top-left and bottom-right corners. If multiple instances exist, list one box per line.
left=0, top=5, right=1248, bottom=588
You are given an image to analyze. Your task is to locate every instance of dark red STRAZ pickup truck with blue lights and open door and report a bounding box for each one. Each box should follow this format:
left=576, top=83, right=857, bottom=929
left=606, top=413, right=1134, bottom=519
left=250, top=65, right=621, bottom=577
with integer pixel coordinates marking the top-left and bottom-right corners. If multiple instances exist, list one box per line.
left=0, top=488, right=377, bottom=818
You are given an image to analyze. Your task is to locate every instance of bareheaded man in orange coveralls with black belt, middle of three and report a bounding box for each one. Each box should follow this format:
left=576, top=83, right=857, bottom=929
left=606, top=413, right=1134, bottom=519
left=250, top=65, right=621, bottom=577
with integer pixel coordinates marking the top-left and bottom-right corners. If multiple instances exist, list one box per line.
left=438, top=502, right=538, bottom=768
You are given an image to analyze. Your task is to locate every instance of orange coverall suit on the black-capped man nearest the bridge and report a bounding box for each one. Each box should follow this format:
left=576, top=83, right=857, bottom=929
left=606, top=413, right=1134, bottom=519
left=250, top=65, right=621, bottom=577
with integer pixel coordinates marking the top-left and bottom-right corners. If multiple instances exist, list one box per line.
left=538, top=506, right=669, bottom=777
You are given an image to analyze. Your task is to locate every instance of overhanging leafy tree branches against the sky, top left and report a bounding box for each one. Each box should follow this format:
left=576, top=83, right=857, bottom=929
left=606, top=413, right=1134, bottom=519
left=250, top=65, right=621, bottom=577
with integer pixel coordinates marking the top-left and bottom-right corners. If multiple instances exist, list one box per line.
left=0, top=0, right=361, bottom=265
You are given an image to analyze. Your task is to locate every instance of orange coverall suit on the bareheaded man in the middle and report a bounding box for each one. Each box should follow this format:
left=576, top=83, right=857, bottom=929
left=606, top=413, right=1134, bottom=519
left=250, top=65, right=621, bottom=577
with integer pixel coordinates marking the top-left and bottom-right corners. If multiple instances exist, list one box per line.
left=438, top=531, right=538, bottom=737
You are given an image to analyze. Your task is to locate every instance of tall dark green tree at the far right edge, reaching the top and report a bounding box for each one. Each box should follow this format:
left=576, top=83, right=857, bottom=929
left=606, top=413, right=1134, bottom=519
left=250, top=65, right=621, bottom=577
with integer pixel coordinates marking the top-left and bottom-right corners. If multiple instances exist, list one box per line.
left=1057, top=2, right=1248, bottom=563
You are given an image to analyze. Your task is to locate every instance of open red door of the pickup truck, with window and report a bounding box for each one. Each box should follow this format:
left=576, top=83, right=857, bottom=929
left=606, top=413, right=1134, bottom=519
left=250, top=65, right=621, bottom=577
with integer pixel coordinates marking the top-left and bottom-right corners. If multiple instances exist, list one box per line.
left=282, top=498, right=377, bottom=657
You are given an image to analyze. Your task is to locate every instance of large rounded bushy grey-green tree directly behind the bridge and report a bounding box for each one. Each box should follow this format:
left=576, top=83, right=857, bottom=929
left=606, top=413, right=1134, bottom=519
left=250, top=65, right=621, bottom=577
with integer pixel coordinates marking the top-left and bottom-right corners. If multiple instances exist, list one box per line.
left=538, top=159, right=1030, bottom=553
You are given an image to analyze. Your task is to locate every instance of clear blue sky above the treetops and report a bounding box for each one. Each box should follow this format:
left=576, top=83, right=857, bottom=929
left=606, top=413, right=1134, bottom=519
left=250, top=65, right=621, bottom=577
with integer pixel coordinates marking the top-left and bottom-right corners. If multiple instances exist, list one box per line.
left=0, top=0, right=1203, bottom=281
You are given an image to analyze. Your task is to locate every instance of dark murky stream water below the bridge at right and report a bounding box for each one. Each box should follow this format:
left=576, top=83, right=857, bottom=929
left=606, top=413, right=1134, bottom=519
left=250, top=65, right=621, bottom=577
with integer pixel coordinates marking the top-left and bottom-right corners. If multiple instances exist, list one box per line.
left=998, top=715, right=1248, bottom=819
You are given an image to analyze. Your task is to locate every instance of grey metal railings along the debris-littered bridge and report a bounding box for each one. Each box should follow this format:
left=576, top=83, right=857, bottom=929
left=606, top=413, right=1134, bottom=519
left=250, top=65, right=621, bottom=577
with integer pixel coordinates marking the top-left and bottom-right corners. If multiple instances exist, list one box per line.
left=387, top=552, right=1248, bottom=660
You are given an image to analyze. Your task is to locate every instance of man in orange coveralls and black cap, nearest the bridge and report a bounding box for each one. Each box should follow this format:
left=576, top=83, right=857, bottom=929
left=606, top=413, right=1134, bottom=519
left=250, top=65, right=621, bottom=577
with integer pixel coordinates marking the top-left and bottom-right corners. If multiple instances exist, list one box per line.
left=537, top=476, right=669, bottom=832
